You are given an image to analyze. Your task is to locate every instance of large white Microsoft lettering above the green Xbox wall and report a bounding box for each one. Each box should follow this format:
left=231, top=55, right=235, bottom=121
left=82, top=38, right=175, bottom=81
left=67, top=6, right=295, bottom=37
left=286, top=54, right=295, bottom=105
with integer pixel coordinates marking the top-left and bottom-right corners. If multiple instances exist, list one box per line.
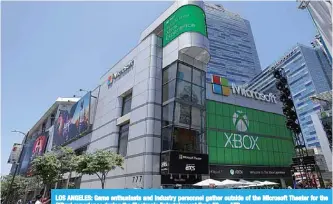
left=231, top=83, right=276, bottom=103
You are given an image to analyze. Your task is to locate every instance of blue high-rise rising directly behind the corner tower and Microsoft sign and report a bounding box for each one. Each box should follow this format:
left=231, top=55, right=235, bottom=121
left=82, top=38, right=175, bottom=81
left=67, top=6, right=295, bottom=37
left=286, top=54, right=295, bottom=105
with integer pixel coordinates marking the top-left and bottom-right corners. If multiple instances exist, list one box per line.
left=205, top=3, right=261, bottom=85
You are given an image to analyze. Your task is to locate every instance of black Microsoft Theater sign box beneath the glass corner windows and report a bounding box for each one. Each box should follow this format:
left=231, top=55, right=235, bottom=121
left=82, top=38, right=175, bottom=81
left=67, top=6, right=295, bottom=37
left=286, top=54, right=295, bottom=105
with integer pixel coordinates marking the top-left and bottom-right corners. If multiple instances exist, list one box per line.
left=161, top=151, right=208, bottom=174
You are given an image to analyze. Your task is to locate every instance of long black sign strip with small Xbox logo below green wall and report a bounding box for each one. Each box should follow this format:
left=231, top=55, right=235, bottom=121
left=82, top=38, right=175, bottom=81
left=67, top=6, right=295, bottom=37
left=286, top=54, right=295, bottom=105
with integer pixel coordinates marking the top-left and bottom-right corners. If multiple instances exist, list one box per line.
left=209, top=165, right=291, bottom=179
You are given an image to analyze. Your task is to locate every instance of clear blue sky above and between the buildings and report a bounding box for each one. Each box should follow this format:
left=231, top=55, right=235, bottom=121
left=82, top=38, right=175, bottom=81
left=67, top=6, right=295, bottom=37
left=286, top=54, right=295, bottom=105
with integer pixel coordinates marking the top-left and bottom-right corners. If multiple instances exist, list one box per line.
left=1, top=1, right=316, bottom=175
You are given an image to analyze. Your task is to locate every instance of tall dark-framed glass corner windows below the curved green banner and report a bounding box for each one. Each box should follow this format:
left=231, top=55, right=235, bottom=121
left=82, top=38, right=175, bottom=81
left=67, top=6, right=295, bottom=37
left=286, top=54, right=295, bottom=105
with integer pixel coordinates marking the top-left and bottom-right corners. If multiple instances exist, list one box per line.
left=162, top=61, right=207, bottom=153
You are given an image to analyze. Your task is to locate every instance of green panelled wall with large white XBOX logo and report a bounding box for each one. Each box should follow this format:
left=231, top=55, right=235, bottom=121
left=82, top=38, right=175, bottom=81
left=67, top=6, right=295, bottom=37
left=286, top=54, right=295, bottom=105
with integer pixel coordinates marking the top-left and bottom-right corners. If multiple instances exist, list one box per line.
left=207, top=101, right=294, bottom=166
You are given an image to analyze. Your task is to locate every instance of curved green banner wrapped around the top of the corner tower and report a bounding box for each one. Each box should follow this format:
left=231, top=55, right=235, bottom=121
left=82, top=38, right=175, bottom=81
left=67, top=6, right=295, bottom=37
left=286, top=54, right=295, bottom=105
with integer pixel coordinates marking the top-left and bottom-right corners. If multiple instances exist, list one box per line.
left=163, top=5, right=207, bottom=47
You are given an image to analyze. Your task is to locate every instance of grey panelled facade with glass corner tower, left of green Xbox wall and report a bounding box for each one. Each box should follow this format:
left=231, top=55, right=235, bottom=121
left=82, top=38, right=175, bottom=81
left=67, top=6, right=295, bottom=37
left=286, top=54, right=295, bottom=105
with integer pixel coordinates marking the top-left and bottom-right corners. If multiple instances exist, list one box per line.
left=81, top=1, right=209, bottom=188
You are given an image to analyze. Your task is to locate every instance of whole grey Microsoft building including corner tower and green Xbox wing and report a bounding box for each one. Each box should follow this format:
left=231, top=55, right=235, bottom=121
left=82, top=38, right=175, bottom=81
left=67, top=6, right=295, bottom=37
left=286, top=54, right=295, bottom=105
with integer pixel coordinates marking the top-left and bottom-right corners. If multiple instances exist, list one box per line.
left=80, top=1, right=293, bottom=188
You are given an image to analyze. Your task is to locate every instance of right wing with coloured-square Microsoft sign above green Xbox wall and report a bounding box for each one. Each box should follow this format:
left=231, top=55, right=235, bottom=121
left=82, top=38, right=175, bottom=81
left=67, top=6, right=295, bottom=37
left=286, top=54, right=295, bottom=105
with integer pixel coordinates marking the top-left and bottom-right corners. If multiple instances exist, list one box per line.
left=206, top=75, right=294, bottom=186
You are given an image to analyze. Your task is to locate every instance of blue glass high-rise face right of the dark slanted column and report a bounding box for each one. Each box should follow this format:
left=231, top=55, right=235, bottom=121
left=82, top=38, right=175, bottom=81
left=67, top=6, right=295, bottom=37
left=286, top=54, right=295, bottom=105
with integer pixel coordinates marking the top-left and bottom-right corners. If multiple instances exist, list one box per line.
left=283, top=46, right=332, bottom=147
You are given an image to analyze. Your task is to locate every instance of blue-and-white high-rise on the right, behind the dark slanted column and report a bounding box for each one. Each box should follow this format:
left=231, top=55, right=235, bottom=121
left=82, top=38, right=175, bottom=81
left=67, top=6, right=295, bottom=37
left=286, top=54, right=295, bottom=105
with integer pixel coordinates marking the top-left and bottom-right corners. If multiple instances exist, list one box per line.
left=246, top=44, right=332, bottom=147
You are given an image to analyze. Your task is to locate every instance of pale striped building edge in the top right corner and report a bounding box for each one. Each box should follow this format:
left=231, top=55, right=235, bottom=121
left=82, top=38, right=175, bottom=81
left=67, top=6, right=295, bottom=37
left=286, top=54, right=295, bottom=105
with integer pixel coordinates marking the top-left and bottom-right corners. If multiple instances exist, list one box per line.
left=298, top=0, right=332, bottom=60
